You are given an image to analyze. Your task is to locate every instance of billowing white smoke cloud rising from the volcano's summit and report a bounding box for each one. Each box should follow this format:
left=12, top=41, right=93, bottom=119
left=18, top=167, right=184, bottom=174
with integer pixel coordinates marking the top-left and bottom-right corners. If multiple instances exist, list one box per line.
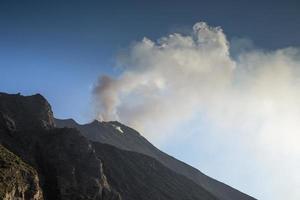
left=93, top=22, right=300, bottom=200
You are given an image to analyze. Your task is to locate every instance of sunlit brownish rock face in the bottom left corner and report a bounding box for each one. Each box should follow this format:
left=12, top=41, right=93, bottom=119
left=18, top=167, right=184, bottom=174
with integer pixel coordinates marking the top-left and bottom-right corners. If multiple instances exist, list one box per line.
left=0, top=145, right=43, bottom=200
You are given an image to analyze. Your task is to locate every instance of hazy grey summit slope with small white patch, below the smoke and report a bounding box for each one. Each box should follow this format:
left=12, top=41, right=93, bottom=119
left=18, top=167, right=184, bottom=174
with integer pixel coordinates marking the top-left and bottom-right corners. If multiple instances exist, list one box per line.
left=55, top=119, right=254, bottom=200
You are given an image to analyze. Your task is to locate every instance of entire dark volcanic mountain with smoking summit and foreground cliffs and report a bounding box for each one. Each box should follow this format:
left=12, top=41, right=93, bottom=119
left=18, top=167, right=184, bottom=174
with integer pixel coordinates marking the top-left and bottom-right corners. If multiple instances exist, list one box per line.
left=0, top=93, right=253, bottom=200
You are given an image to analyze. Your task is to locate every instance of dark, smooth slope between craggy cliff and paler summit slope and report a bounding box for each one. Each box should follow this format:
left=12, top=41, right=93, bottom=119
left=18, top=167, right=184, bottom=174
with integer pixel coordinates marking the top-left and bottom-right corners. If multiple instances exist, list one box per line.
left=94, top=142, right=217, bottom=200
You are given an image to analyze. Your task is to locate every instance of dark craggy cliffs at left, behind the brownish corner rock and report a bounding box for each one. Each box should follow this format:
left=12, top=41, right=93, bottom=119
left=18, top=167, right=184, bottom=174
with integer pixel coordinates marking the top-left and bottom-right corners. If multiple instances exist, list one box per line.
left=0, top=93, right=121, bottom=200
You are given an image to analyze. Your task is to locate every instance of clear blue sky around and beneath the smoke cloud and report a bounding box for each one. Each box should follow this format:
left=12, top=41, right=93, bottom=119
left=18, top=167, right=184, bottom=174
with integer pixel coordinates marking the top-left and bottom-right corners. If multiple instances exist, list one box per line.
left=0, top=0, right=300, bottom=200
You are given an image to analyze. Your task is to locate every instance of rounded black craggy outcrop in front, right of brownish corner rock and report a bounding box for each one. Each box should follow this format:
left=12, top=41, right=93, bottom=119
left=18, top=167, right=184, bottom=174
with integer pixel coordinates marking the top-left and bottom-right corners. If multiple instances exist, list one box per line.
left=36, top=128, right=119, bottom=200
